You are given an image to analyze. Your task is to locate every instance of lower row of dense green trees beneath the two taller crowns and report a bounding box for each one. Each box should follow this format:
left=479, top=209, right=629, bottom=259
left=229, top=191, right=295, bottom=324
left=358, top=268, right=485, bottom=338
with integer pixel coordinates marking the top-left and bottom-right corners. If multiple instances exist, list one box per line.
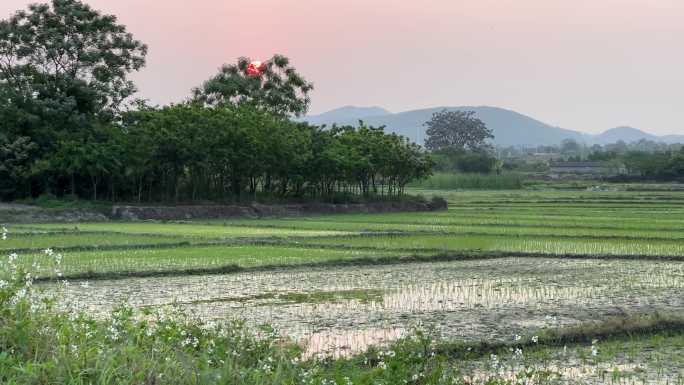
left=0, top=103, right=432, bottom=201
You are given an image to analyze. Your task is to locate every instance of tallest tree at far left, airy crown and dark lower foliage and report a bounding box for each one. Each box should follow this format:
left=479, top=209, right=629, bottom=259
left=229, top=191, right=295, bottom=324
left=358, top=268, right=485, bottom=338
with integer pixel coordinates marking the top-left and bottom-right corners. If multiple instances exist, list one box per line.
left=0, top=0, right=147, bottom=196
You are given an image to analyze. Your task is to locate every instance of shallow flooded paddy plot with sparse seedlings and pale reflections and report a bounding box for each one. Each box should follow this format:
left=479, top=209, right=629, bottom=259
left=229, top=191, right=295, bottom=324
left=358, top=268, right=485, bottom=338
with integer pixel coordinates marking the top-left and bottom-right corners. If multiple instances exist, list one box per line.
left=54, top=258, right=684, bottom=355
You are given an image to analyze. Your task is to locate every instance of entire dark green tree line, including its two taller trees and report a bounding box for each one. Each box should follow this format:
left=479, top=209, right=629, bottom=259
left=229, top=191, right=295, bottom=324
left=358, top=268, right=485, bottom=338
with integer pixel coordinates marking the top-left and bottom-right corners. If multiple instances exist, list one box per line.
left=0, top=0, right=433, bottom=202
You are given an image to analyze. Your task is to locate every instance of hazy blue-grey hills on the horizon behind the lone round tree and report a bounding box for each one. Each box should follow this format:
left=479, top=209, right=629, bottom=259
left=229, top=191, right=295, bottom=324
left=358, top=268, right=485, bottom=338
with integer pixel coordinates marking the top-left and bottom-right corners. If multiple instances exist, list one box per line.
left=303, top=106, right=684, bottom=146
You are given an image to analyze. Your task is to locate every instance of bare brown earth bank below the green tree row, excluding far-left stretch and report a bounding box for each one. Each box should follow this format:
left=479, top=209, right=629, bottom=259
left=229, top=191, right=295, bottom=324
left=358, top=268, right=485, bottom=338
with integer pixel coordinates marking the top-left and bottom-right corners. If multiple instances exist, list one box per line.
left=111, top=199, right=447, bottom=220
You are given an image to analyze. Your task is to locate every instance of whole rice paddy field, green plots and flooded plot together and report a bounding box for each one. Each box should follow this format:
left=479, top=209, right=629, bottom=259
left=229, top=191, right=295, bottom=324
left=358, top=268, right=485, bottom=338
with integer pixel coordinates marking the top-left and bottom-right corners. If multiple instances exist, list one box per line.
left=0, top=190, right=684, bottom=385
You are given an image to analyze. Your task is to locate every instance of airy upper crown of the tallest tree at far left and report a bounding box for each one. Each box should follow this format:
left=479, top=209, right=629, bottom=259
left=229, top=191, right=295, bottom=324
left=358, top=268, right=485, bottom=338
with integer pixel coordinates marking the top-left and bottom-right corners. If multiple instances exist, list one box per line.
left=0, top=0, right=147, bottom=114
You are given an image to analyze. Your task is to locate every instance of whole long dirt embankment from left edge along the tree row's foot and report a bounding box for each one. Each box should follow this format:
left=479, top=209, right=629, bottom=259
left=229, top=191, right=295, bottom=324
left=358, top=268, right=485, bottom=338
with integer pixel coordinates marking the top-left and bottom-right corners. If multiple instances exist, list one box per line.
left=0, top=198, right=447, bottom=224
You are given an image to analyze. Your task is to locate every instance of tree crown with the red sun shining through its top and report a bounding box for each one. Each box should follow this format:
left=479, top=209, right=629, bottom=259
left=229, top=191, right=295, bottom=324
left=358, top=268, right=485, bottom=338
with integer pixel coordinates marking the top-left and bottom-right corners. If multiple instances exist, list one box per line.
left=193, top=55, right=313, bottom=116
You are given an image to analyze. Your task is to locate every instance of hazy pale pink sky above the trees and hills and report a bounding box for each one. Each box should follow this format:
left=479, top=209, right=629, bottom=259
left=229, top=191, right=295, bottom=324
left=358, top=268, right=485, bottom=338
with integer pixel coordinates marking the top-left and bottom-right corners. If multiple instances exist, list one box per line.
left=0, top=0, right=684, bottom=134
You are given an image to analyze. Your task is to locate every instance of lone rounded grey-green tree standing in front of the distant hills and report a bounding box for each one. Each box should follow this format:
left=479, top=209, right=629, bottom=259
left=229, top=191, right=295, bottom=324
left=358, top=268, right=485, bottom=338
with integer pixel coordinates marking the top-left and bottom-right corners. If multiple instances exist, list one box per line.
left=425, top=110, right=494, bottom=152
